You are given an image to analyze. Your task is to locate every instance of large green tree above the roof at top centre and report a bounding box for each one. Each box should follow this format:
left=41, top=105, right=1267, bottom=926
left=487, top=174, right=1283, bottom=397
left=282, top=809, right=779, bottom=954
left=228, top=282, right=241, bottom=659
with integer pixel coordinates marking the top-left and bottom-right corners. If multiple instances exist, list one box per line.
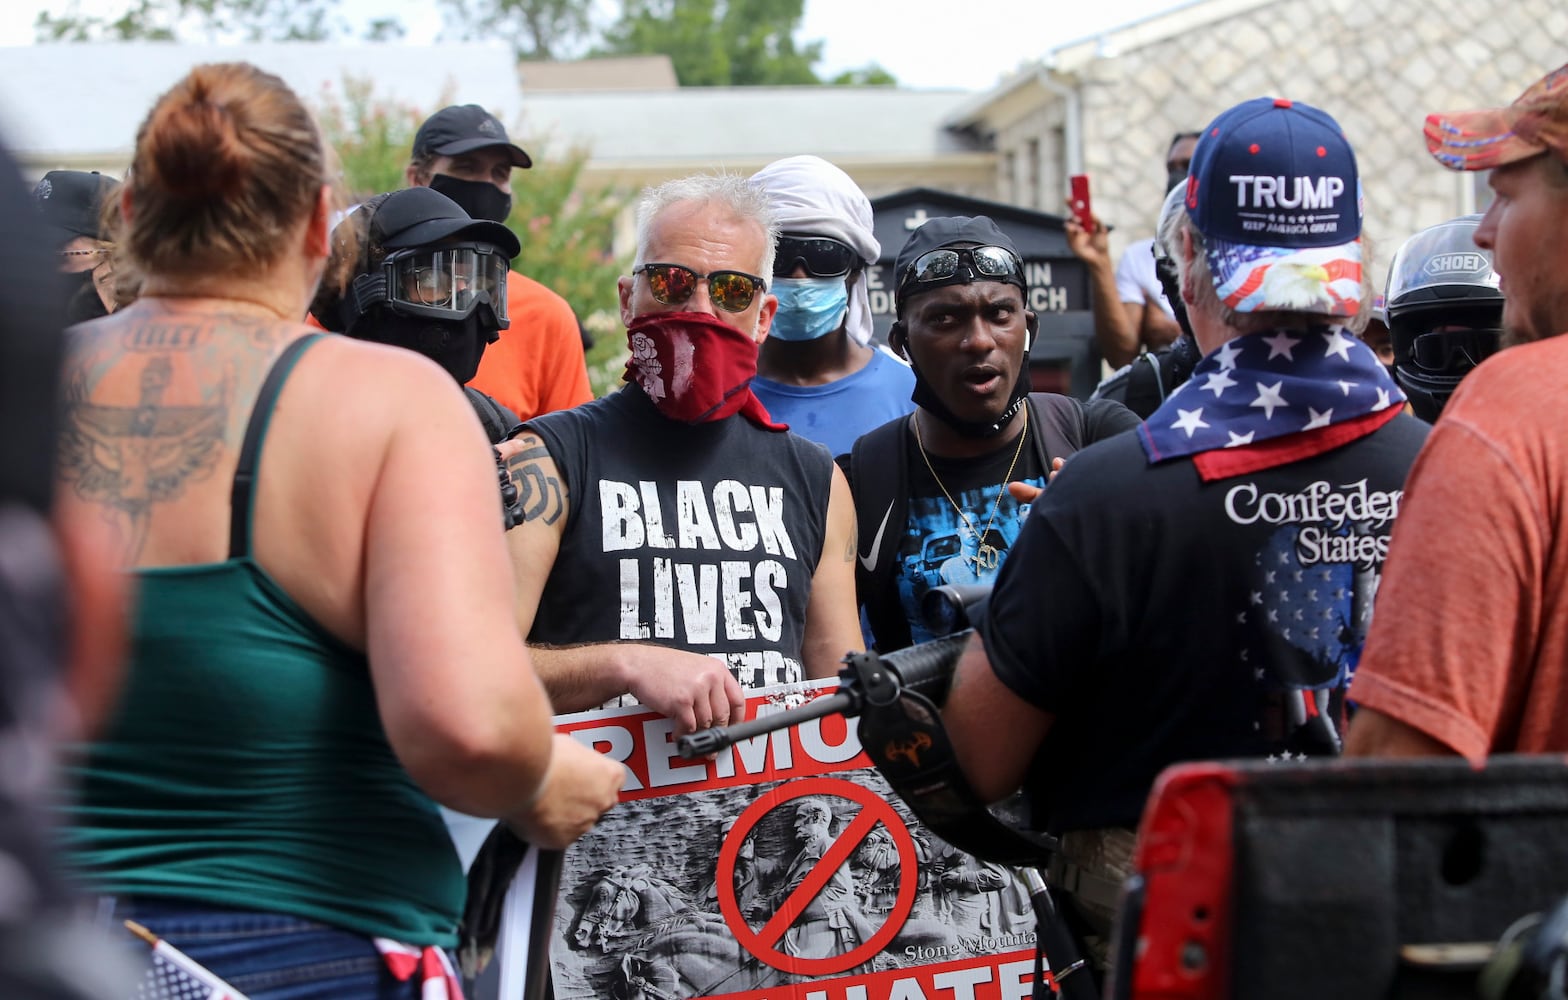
left=599, top=0, right=822, bottom=86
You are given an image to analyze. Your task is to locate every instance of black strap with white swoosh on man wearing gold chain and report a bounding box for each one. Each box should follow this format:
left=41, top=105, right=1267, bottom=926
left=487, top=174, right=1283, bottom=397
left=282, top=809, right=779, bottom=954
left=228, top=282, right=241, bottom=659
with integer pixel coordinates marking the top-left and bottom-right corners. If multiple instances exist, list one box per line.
left=845, top=415, right=913, bottom=649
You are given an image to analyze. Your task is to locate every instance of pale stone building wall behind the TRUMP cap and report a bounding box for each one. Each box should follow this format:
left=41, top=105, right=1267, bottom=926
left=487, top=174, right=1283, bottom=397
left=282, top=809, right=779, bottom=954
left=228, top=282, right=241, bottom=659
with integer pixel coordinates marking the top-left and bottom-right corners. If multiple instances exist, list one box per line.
left=1059, top=0, right=1568, bottom=287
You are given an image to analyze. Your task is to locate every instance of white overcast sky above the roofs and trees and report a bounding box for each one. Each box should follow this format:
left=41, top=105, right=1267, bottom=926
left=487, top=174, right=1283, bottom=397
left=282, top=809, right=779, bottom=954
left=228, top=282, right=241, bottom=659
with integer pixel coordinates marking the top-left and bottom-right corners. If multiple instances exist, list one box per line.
left=0, top=0, right=1182, bottom=91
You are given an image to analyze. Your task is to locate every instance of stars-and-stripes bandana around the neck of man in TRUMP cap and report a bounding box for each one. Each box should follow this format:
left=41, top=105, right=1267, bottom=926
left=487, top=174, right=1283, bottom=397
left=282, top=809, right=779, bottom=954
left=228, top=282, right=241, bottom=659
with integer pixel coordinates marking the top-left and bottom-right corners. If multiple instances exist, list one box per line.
left=1138, top=326, right=1405, bottom=478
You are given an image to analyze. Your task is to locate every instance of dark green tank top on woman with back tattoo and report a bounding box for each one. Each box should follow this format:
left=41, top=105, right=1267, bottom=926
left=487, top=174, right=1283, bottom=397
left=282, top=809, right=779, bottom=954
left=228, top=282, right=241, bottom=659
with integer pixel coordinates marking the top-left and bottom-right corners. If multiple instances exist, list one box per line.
left=66, top=335, right=464, bottom=948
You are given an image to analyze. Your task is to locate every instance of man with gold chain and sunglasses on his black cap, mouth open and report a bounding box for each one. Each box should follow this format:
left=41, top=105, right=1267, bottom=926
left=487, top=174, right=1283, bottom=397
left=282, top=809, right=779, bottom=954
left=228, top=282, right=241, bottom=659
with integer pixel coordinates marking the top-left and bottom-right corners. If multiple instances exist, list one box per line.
left=848, top=215, right=1138, bottom=652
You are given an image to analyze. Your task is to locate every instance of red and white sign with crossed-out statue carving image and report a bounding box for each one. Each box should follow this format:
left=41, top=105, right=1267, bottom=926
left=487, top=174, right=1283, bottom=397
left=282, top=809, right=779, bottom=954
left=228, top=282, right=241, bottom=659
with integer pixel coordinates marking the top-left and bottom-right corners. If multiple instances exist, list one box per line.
left=526, top=682, right=1053, bottom=1000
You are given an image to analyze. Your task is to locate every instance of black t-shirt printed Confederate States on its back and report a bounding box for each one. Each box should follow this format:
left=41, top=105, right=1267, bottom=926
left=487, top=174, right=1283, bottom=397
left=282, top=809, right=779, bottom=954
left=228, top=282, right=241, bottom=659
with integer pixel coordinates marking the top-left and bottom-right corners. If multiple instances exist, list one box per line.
left=980, top=415, right=1427, bottom=832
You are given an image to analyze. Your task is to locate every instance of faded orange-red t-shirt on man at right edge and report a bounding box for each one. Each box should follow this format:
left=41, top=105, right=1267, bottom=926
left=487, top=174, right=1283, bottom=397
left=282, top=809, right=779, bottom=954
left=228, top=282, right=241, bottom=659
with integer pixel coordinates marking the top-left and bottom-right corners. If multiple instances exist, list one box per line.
left=1350, top=335, right=1568, bottom=763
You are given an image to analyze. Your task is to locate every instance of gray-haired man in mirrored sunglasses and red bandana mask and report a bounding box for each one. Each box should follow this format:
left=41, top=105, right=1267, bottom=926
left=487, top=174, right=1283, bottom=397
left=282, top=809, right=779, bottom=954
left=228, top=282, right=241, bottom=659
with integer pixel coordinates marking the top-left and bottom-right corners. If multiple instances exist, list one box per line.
left=511, top=176, right=861, bottom=732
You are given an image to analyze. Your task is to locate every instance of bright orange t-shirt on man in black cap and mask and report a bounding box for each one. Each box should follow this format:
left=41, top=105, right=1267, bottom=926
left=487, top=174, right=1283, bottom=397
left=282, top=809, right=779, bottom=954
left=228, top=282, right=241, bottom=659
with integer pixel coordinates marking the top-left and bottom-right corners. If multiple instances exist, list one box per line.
left=469, top=271, right=593, bottom=420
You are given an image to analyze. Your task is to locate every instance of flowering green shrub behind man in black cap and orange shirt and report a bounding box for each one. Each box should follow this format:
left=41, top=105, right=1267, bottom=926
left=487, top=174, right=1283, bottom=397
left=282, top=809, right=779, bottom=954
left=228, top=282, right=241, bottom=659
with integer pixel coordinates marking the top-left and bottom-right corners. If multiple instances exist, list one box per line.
left=317, top=80, right=630, bottom=393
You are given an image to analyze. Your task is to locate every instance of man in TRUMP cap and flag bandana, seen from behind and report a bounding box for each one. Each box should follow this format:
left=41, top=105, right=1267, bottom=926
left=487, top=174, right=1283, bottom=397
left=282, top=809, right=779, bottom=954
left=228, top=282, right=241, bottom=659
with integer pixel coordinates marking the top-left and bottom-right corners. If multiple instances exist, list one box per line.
left=942, top=97, right=1425, bottom=971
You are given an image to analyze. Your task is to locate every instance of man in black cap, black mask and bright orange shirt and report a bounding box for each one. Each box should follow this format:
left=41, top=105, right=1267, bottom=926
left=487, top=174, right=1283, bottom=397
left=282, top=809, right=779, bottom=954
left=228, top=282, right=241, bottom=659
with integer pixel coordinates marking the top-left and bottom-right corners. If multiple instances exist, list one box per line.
left=403, top=103, right=593, bottom=420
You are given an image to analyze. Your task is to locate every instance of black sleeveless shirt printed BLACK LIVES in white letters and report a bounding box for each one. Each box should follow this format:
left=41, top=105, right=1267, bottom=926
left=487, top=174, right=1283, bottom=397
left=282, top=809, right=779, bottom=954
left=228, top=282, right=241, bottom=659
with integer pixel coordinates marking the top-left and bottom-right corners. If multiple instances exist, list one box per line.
left=528, top=384, right=833, bottom=687
